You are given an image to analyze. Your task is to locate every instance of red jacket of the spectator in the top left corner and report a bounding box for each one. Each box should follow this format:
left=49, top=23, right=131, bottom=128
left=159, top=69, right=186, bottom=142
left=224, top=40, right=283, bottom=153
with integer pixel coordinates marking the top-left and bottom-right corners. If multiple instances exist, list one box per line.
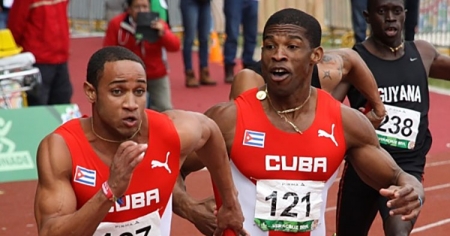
left=8, top=0, right=70, bottom=64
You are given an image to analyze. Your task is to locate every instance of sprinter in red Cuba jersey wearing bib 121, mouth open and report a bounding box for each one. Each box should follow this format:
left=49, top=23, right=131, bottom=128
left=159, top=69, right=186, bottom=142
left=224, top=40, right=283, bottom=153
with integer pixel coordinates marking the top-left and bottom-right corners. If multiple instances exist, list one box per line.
left=174, top=9, right=424, bottom=236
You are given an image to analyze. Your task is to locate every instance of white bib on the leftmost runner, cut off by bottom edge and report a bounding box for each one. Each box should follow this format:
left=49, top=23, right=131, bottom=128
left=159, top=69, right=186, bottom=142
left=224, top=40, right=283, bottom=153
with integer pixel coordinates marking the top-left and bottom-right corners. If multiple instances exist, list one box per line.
left=94, top=211, right=161, bottom=236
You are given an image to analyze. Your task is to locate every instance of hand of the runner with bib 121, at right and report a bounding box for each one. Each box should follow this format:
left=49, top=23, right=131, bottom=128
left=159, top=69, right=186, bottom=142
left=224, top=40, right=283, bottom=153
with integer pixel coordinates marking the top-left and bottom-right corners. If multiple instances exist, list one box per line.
left=380, top=184, right=424, bottom=221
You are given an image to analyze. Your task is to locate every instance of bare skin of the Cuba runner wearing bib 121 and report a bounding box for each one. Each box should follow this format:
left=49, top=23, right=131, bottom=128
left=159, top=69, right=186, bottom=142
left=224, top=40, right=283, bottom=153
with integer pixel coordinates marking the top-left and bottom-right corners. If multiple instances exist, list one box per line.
left=174, top=24, right=424, bottom=236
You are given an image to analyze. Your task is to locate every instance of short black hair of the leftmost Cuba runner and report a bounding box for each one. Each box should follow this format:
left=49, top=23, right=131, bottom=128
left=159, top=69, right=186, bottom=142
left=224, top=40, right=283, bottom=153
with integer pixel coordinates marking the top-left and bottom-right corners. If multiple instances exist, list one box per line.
left=86, top=46, right=145, bottom=89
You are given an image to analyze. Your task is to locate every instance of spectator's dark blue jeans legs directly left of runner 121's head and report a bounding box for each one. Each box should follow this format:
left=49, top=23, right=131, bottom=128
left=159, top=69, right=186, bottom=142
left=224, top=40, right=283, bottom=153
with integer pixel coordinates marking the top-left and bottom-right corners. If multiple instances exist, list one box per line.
left=223, top=0, right=258, bottom=83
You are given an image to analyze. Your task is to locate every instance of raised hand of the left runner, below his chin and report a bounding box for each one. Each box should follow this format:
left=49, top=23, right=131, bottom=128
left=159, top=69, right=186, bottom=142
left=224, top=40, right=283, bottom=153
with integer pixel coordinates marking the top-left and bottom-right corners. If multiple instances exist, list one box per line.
left=108, top=141, right=147, bottom=197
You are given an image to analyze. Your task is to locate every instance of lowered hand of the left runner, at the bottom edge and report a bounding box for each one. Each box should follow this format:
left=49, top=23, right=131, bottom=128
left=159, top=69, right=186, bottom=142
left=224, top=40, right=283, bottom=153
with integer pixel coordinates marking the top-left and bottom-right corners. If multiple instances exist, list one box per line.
left=214, top=200, right=249, bottom=236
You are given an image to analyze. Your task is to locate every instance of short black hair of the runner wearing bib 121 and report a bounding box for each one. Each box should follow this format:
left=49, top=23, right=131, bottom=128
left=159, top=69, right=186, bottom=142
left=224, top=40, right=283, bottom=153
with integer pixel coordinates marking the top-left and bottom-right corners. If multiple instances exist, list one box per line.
left=263, top=8, right=322, bottom=48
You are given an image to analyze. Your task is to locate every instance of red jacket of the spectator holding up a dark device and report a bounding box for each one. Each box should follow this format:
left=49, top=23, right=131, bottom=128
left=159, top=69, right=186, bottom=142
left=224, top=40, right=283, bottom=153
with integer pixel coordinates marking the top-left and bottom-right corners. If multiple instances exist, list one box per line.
left=103, top=13, right=180, bottom=79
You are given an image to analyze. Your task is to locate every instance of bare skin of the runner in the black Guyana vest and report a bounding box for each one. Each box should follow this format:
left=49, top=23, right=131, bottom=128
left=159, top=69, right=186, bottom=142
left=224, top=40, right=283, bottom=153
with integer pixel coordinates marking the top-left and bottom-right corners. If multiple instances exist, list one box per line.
left=330, top=0, right=450, bottom=235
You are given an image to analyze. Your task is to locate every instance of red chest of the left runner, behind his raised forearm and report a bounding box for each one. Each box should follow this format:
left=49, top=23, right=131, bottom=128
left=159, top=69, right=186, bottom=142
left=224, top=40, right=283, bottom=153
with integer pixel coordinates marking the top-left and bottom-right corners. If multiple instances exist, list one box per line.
left=72, top=145, right=179, bottom=219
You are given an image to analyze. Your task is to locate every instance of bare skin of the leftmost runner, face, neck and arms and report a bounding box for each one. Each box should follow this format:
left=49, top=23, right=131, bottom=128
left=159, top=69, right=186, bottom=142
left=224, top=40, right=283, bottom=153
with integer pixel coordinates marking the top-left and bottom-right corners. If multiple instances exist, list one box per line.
left=35, top=60, right=244, bottom=235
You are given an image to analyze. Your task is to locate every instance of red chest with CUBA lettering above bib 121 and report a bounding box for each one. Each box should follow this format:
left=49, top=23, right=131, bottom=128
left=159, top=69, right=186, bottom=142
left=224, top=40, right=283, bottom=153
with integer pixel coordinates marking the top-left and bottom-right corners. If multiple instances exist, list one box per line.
left=231, top=123, right=345, bottom=181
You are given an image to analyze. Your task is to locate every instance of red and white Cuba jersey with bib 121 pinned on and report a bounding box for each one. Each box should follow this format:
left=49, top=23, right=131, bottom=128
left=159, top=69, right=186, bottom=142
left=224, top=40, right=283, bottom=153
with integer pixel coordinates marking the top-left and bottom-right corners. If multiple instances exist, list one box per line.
left=230, top=89, right=346, bottom=236
